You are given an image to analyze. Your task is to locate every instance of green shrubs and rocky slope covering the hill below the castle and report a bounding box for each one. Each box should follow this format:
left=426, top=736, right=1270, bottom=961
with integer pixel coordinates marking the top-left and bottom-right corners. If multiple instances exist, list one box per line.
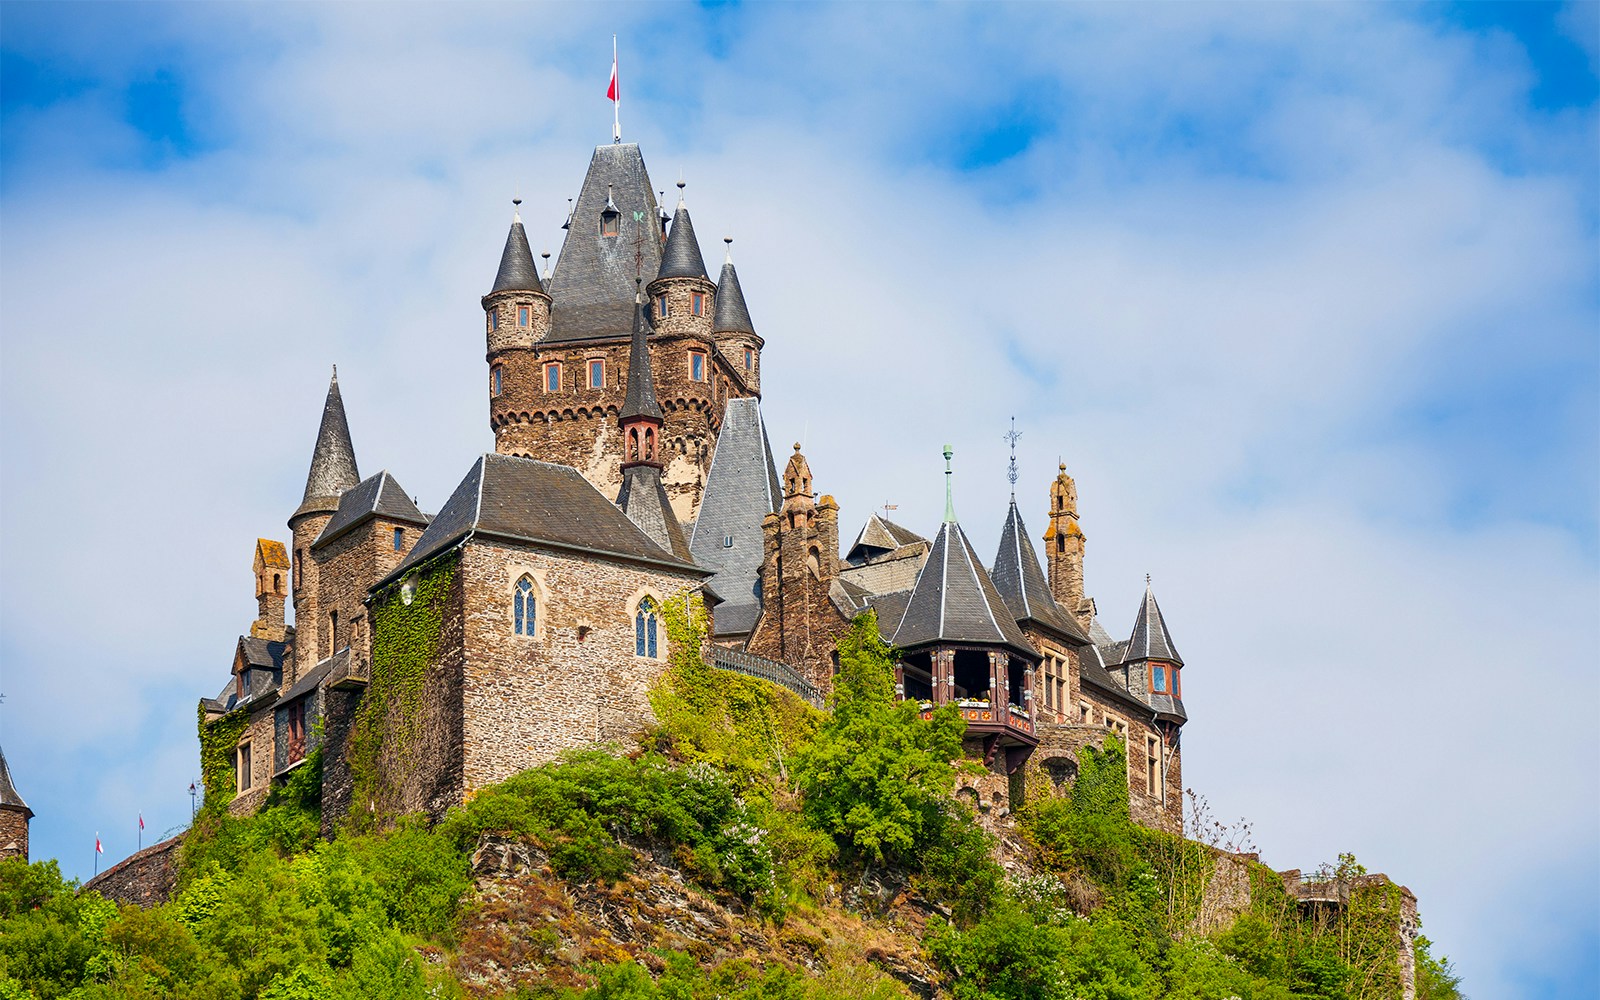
left=0, top=602, right=1461, bottom=1000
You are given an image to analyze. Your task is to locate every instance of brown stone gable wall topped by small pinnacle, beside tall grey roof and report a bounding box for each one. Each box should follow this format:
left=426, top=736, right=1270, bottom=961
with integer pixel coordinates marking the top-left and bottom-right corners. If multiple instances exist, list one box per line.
left=747, top=445, right=850, bottom=690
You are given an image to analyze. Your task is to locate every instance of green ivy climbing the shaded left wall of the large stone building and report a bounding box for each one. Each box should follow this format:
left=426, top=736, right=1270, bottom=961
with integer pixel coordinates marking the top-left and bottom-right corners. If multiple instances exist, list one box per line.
left=346, top=555, right=459, bottom=822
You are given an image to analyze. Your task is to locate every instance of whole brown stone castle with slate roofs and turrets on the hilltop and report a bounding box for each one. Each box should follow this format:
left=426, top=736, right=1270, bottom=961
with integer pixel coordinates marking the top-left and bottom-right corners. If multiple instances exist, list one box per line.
left=200, top=142, right=1186, bottom=829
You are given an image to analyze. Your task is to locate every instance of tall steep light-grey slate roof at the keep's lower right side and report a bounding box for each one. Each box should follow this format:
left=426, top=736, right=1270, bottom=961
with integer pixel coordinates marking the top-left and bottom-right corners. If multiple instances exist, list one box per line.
left=690, top=398, right=782, bottom=635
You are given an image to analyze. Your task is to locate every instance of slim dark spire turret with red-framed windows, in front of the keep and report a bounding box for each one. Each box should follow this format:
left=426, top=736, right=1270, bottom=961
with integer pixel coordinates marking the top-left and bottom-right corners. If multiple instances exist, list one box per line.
left=616, top=294, right=691, bottom=562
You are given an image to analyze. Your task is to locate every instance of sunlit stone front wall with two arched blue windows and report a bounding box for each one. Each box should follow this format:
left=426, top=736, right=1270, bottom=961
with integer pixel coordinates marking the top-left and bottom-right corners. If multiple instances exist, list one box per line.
left=459, top=542, right=699, bottom=790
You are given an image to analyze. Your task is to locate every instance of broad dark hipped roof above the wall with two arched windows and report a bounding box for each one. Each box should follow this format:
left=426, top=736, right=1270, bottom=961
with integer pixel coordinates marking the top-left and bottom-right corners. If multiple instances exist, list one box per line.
left=378, top=451, right=702, bottom=586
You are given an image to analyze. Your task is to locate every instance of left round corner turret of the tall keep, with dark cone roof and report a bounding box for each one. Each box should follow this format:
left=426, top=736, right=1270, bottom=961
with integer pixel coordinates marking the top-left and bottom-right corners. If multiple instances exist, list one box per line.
left=482, top=198, right=562, bottom=458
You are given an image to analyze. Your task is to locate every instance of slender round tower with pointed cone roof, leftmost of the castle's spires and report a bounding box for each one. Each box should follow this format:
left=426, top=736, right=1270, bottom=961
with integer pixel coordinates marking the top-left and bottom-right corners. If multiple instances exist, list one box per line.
left=290, top=368, right=362, bottom=677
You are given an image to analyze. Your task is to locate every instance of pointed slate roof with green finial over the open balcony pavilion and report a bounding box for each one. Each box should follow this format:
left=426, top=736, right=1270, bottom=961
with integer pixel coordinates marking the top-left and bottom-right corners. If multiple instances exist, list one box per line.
left=893, top=520, right=1038, bottom=659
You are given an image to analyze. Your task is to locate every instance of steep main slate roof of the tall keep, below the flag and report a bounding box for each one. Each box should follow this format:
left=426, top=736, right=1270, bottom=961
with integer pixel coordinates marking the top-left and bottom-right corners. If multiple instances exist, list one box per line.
left=546, top=142, right=661, bottom=341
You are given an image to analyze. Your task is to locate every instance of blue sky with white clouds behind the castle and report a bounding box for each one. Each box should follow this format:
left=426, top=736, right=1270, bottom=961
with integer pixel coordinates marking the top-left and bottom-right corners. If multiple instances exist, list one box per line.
left=0, top=3, right=1600, bottom=1000
